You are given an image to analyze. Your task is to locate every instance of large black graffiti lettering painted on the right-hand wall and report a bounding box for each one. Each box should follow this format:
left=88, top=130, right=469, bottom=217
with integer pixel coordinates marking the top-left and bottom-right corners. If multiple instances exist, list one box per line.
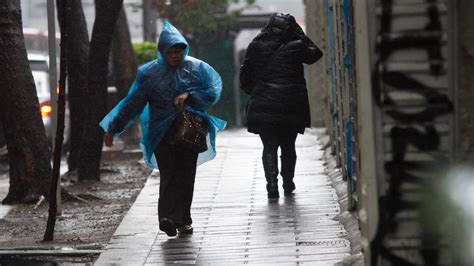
left=371, top=0, right=453, bottom=265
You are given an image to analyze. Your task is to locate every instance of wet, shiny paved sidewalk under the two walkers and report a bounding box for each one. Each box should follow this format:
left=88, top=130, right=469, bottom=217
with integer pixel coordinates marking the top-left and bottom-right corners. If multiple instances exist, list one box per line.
left=96, top=130, right=350, bottom=265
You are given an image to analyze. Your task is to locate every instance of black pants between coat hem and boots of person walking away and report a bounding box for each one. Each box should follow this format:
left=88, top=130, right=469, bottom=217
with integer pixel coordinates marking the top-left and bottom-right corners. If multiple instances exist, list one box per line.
left=259, top=130, right=298, bottom=158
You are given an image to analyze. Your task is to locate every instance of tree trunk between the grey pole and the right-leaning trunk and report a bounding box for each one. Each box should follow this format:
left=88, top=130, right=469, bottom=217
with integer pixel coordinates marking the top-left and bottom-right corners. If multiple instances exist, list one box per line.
left=62, top=0, right=89, bottom=171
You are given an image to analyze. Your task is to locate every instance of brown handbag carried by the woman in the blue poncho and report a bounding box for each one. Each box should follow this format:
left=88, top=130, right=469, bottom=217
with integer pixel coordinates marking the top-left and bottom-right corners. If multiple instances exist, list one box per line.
left=173, top=111, right=209, bottom=153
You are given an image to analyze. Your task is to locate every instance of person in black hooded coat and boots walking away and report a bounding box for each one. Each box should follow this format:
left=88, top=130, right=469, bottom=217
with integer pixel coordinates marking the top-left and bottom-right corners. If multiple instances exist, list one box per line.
left=240, top=13, right=323, bottom=198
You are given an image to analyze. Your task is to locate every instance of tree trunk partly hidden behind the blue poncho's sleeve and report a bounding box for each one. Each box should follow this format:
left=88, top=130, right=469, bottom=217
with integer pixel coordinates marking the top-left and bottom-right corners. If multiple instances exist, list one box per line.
left=112, top=8, right=140, bottom=145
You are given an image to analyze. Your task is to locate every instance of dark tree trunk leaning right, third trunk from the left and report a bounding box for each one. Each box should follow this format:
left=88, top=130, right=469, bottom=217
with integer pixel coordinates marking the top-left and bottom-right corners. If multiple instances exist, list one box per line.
left=78, top=0, right=123, bottom=181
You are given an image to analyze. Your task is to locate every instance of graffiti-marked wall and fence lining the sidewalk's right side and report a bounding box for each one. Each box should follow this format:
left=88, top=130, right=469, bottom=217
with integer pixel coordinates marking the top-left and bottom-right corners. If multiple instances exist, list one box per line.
left=306, top=0, right=474, bottom=265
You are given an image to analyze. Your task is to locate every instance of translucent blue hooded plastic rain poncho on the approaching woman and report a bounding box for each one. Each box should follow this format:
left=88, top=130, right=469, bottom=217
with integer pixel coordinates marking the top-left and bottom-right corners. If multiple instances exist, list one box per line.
left=100, top=21, right=226, bottom=168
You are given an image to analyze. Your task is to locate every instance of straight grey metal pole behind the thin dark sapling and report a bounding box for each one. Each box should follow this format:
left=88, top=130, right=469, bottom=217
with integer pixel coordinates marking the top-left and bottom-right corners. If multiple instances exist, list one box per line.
left=46, top=0, right=62, bottom=215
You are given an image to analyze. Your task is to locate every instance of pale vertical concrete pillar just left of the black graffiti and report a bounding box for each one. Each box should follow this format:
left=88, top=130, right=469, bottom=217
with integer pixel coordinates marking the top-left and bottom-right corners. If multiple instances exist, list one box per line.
left=353, top=1, right=379, bottom=265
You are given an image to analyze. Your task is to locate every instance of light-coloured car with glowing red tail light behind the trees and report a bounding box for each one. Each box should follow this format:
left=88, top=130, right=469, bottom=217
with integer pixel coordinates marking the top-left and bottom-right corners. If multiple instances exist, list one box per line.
left=0, top=52, right=69, bottom=151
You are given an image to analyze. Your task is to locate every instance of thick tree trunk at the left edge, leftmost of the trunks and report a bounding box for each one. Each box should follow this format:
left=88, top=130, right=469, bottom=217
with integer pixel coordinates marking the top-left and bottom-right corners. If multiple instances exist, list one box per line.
left=0, top=0, right=51, bottom=204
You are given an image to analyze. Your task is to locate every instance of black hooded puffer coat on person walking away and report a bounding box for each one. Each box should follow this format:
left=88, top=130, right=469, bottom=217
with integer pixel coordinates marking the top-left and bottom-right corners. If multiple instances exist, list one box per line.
left=240, top=13, right=323, bottom=134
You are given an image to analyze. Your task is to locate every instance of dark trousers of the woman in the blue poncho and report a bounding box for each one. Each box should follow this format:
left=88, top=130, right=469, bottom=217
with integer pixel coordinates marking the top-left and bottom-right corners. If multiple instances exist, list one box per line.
left=155, top=140, right=198, bottom=227
